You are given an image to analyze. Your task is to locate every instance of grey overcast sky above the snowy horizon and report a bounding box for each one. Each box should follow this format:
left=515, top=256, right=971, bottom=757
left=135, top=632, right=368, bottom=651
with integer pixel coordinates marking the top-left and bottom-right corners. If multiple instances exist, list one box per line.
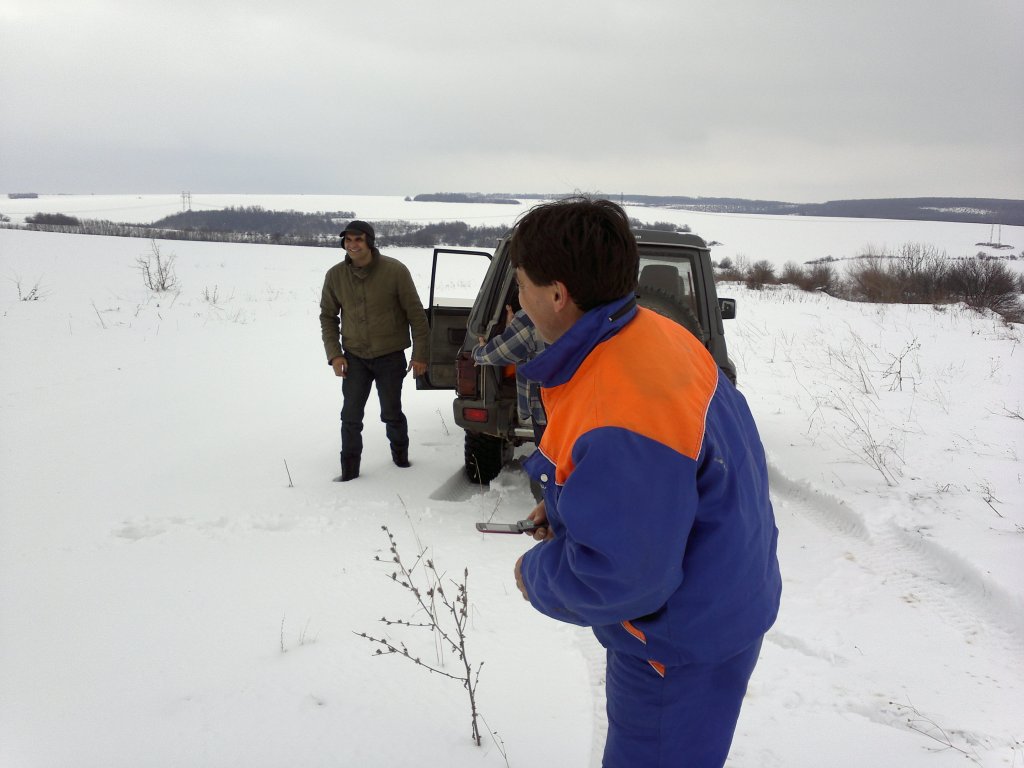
left=0, top=0, right=1024, bottom=203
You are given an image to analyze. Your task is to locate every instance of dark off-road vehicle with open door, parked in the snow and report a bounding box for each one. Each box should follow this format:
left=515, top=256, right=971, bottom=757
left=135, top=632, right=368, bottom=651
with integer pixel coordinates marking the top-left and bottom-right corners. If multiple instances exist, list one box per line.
left=417, top=229, right=736, bottom=483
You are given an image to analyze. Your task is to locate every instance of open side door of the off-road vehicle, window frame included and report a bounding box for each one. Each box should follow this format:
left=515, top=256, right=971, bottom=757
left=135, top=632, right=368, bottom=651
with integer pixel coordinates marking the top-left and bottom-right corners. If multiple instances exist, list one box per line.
left=416, top=248, right=492, bottom=389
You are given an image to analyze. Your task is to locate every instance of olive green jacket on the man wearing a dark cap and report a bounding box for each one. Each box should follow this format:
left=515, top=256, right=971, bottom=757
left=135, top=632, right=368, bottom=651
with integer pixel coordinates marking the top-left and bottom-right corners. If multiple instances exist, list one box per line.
left=321, top=249, right=430, bottom=362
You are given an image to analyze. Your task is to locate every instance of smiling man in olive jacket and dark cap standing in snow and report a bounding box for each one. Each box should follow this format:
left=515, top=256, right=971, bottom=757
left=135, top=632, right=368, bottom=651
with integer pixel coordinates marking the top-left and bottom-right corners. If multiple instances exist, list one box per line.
left=321, top=221, right=429, bottom=482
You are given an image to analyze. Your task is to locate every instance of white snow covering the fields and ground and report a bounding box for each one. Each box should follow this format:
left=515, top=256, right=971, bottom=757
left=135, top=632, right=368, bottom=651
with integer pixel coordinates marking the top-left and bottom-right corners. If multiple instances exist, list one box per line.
left=0, top=195, right=1024, bottom=768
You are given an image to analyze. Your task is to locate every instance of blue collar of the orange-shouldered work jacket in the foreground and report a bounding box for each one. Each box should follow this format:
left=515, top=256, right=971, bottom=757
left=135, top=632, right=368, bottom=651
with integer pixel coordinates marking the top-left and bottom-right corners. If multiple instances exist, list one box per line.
left=520, top=294, right=637, bottom=387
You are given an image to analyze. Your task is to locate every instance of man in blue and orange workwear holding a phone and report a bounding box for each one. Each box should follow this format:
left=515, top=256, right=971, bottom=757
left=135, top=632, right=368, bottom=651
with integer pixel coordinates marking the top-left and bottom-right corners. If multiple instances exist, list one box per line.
left=510, top=198, right=781, bottom=768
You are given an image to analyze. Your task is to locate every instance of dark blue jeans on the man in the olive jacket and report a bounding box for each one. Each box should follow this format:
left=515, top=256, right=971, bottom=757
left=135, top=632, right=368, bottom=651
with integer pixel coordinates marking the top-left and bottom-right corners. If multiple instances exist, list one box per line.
left=341, top=351, right=409, bottom=456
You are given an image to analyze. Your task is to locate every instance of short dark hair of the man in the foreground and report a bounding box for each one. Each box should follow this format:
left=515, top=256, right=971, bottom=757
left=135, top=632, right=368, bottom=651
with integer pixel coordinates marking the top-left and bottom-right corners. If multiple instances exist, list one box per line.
left=509, top=196, right=640, bottom=311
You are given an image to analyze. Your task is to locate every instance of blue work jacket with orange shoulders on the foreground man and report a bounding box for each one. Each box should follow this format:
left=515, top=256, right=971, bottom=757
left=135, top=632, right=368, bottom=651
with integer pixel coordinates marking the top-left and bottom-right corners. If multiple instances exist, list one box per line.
left=522, top=296, right=781, bottom=674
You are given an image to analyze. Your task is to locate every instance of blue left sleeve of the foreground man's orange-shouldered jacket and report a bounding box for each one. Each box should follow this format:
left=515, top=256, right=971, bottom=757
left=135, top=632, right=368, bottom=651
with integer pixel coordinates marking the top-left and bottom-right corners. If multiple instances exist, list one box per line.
left=522, top=427, right=696, bottom=626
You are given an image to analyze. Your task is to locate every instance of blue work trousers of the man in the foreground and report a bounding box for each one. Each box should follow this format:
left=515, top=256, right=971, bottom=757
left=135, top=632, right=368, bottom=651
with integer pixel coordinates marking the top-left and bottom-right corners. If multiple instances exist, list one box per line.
left=603, top=639, right=761, bottom=768
